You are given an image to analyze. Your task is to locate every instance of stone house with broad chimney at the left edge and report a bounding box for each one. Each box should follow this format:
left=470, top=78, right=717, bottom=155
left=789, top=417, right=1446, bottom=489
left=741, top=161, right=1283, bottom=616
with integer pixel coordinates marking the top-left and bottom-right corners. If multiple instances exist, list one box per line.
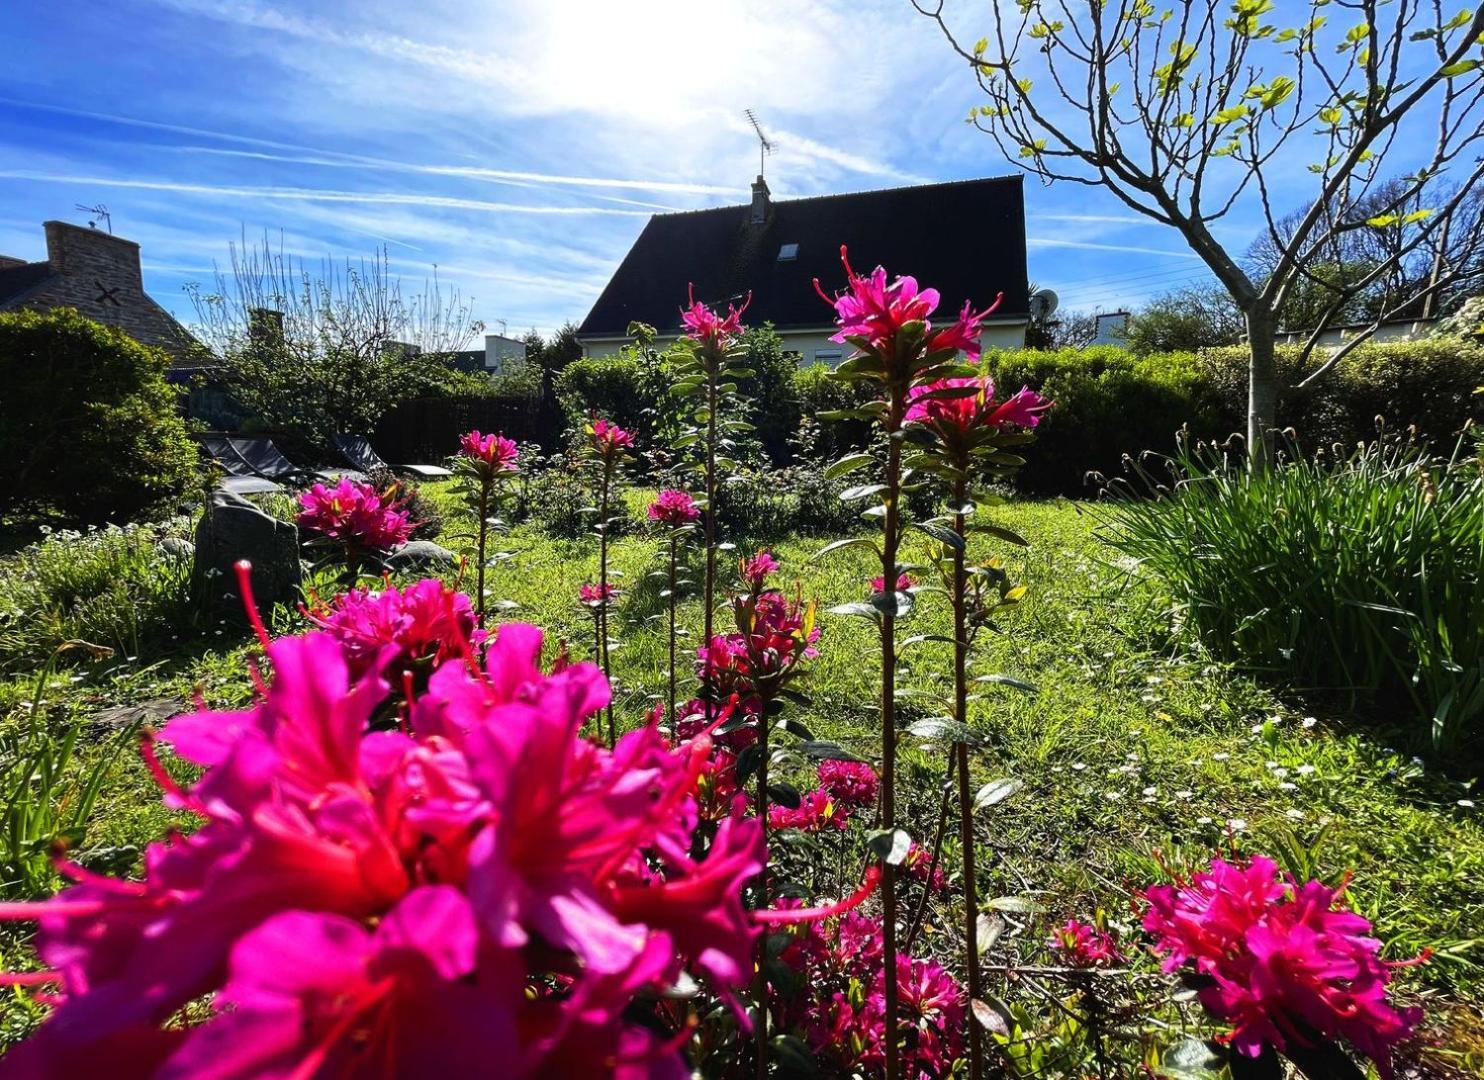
left=0, top=221, right=200, bottom=366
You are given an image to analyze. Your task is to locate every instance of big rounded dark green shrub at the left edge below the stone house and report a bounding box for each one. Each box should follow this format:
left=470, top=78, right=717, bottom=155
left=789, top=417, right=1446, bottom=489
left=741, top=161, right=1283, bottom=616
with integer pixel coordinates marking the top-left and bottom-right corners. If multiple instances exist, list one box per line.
left=0, top=309, right=197, bottom=524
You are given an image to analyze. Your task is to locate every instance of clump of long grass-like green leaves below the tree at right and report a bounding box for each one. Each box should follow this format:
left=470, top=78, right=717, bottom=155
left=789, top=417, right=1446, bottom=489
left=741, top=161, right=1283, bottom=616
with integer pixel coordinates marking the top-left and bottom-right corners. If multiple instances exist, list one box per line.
left=1104, top=436, right=1484, bottom=770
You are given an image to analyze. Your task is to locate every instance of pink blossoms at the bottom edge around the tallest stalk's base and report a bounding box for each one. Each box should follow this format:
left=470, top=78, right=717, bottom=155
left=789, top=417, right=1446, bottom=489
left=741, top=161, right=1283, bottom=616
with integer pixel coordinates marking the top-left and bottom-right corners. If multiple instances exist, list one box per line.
left=776, top=911, right=968, bottom=1077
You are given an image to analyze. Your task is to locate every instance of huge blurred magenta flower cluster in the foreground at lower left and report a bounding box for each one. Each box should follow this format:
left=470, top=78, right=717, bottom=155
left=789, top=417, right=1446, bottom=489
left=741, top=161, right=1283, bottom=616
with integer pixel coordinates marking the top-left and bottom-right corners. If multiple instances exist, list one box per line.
left=0, top=608, right=763, bottom=1077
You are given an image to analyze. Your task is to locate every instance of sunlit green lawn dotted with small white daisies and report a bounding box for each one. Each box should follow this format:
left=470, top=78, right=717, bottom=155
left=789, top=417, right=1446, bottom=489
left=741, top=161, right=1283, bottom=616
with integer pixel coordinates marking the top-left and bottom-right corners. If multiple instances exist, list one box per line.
left=0, top=485, right=1484, bottom=1068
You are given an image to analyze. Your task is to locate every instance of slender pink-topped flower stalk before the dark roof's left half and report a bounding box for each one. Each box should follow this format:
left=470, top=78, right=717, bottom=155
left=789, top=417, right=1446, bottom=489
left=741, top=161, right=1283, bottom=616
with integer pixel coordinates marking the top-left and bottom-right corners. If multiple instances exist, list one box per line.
left=674, top=288, right=752, bottom=720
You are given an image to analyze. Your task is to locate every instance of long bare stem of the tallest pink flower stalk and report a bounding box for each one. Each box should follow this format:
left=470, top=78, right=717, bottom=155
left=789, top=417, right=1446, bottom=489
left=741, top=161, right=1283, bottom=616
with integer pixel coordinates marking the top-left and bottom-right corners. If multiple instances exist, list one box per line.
left=881, top=386, right=907, bottom=1080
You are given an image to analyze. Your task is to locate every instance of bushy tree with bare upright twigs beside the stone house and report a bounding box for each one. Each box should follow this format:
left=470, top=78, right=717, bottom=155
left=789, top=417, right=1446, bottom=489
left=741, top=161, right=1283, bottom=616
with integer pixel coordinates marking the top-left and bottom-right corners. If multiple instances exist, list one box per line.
left=187, top=234, right=482, bottom=445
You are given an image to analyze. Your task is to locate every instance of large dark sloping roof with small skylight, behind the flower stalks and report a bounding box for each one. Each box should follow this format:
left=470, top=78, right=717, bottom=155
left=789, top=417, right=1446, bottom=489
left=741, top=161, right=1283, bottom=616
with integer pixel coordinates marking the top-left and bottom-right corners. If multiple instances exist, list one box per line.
left=577, top=175, right=1028, bottom=337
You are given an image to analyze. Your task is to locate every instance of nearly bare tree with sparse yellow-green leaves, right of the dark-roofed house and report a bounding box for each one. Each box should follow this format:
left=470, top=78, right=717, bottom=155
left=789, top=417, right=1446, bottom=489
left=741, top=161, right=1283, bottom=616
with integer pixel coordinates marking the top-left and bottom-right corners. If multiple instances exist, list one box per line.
left=913, top=0, right=1484, bottom=455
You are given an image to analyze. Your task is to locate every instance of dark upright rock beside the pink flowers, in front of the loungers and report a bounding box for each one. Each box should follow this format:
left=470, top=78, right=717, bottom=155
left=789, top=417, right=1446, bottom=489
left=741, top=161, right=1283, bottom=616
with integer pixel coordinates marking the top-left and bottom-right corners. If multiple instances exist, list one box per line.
left=191, top=491, right=303, bottom=617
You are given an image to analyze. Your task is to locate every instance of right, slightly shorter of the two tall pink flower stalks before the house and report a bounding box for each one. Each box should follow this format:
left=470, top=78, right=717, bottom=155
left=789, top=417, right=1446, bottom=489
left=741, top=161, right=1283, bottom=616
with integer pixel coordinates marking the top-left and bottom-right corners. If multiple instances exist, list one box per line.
left=904, top=364, right=1051, bottom=1080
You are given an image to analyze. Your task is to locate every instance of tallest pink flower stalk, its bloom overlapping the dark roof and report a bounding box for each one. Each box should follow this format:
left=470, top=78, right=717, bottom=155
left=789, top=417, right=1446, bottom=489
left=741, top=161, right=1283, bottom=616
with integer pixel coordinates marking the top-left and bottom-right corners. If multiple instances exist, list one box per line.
left=815, top=248, right=1003, bottom=1080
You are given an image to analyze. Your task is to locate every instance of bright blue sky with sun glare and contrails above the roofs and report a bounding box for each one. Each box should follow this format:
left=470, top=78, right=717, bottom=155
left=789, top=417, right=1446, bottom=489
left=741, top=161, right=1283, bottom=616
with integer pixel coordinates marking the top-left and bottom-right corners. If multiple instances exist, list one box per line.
left=0, top=0, right=1222, bottom=332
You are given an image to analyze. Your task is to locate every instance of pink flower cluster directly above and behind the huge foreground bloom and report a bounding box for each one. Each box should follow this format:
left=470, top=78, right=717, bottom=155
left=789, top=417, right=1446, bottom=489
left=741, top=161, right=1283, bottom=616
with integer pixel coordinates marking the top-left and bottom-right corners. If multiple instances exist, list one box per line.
left=307, top=577, right=485, bottom=678
